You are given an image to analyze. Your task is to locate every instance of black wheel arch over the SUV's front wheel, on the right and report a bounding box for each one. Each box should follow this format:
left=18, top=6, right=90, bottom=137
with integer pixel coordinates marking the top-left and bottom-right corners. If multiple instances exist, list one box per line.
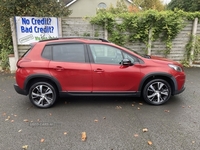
left=139, top=72, right=178, bottom=95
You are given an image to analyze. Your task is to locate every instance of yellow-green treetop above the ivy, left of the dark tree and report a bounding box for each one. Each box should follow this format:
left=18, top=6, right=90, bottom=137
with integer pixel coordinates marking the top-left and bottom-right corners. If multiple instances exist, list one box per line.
left=134, top=0, right=165, bottom=11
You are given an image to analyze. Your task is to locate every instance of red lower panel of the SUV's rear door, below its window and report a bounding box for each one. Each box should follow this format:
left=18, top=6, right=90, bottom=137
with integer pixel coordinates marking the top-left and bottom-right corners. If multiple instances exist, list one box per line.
left=49, top=61, right=92, bottom=92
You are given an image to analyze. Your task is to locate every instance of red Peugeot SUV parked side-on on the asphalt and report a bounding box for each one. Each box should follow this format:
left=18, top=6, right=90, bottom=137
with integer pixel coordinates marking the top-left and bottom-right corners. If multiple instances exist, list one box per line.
left=14, top=37, right=185, bottom=108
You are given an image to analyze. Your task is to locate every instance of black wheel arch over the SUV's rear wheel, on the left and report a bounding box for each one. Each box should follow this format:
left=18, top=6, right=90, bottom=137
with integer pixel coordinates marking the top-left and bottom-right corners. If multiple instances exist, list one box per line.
left=24, top=74, right=62, bottom=94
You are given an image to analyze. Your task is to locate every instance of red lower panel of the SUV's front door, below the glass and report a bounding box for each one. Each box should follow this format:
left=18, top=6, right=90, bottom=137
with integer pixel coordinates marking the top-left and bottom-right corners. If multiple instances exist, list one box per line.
left=92, top=64, right=142, bottom=92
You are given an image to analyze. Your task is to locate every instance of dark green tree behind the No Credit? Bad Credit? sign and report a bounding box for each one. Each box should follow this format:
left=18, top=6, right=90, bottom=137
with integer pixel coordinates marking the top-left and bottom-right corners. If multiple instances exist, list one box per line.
left=0, top=0, right=71, bottom=68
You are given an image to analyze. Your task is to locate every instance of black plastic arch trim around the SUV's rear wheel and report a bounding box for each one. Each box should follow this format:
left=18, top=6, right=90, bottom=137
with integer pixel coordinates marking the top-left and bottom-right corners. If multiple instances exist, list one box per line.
left=24, top=74, right=62, bottom=92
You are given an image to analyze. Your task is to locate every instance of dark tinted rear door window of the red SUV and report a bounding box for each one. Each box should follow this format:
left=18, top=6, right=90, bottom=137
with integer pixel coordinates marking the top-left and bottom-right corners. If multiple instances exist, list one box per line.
left=52, top=44, right=85, bottom=62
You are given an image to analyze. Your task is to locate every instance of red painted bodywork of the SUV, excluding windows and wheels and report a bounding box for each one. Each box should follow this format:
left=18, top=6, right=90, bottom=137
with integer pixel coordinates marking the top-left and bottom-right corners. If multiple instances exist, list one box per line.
left=16, top=39, right=185, bottom=92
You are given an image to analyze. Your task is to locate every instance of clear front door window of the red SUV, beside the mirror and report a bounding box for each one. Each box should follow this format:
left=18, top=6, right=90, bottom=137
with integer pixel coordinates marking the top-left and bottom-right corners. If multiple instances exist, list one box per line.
left=90, top=44, right=123, bottom=65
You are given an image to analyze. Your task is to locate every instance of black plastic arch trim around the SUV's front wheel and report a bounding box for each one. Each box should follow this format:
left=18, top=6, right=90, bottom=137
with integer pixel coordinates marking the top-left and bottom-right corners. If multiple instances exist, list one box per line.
left=138, top=72, right=178, bottom=95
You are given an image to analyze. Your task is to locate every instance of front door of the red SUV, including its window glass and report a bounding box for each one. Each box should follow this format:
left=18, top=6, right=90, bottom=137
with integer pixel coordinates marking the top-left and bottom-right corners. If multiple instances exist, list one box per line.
left=89, top=44, right=141, bottom=92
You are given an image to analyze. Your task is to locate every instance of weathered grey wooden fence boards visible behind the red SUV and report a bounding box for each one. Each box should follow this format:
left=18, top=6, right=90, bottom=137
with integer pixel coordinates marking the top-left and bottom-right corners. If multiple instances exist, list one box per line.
left=12, top=18, right=200, bottom=65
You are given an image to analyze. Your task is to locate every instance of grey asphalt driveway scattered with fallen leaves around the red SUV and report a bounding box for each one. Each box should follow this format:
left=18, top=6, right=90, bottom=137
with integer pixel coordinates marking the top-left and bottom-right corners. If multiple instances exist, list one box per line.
left=0, top=68, right=200, bottom=150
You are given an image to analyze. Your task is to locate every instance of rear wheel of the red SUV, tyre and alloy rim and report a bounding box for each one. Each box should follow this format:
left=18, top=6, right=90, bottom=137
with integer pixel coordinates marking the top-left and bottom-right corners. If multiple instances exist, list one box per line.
left=29, top=82, right=57, bottom=108
